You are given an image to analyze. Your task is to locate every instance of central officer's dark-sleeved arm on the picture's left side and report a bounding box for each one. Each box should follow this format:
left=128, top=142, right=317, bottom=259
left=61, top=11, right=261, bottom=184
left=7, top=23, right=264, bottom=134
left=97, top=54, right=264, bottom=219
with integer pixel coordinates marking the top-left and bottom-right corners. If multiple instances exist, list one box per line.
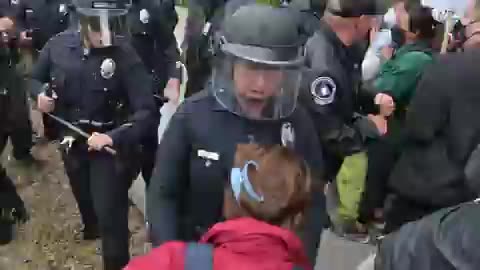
left=147, top=104, right=191, bottom=246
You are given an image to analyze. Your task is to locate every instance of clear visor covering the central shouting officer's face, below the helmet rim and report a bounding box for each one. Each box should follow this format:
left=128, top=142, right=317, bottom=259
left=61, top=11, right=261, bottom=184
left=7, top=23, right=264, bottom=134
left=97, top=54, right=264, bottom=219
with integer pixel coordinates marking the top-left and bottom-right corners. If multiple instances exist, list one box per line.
left=210, top=56, right=301, bottom=120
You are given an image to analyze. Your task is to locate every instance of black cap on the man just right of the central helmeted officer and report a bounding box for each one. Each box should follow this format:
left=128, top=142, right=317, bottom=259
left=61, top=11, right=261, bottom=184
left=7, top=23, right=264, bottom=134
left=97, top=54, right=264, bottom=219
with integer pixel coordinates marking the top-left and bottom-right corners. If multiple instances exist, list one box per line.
left=326, top=0, right=388, bottom=17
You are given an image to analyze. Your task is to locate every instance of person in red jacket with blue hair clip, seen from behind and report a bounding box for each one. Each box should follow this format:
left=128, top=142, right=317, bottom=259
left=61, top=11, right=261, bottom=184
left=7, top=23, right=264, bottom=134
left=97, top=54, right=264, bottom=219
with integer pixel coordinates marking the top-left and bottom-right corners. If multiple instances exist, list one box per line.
left=125, top=144, right=312, bottom=270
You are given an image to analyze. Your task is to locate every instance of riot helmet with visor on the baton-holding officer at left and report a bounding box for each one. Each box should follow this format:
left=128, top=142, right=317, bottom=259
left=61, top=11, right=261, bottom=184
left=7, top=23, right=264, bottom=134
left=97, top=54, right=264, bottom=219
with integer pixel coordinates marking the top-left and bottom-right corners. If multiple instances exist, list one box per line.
left=73, top=0, right=131, bottom=48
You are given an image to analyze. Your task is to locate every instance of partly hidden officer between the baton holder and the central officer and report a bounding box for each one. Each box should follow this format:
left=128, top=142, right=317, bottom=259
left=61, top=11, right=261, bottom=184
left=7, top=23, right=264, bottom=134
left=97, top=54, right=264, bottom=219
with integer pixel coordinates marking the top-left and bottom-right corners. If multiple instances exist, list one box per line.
left=128, top=0, right=181, bottom=186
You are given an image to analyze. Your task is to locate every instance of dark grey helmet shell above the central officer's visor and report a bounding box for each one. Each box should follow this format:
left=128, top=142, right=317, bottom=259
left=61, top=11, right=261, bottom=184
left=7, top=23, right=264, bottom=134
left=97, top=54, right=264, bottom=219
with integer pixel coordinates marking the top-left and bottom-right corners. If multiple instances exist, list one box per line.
left=221, top=5, right=305, bottom=65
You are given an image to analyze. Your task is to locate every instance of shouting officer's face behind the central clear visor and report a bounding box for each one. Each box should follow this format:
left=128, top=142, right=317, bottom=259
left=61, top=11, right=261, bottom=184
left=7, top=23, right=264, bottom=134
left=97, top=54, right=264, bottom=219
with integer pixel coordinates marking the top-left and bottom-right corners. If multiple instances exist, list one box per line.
left=233, top=62, right=282, bottom=102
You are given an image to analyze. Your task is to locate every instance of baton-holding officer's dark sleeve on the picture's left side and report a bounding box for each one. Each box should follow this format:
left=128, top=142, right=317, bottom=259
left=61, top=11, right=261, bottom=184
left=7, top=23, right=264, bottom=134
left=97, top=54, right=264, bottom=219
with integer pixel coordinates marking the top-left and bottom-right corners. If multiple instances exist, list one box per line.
left=30, top=42, right=51, bottom=100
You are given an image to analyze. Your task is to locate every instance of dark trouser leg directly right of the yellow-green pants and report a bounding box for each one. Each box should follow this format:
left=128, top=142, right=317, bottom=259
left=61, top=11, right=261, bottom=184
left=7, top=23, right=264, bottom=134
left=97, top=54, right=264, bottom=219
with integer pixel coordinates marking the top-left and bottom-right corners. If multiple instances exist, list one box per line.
left=358, top=139, right=399, bottom=224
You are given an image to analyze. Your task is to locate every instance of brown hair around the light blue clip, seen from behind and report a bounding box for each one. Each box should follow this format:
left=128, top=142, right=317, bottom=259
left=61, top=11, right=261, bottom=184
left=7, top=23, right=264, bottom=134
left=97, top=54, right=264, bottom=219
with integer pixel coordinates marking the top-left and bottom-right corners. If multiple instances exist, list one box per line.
left=224, top=144, right=312, bottom=229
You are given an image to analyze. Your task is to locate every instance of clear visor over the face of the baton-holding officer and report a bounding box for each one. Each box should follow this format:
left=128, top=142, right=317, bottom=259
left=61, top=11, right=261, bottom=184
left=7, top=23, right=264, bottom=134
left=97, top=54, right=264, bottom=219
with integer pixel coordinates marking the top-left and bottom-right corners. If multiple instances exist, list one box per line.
left=79, top=9, right=128, bottom=48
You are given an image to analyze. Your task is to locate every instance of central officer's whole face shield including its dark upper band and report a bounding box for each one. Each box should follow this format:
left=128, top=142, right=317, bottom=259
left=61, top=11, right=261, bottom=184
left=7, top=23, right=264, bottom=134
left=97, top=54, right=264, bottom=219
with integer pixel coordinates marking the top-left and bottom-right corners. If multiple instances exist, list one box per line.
left=210, top=44, right=303, bottom=120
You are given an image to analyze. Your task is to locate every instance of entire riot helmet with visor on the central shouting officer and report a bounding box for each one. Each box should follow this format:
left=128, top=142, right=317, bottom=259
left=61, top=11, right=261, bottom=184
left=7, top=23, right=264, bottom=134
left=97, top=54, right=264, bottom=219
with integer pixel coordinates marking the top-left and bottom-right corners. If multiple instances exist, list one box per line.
left=210, top=4, right=305, bottom=120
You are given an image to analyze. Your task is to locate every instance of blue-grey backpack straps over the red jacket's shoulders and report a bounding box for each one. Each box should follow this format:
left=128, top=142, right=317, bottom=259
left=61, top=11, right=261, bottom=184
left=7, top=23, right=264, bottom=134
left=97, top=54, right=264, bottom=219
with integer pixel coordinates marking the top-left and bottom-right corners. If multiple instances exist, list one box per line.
left=185, top=242, right=304, bottom=270
